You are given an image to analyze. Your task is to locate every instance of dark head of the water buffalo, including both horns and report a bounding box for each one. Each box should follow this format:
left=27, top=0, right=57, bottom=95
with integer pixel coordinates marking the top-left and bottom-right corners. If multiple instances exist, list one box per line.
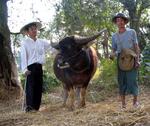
left=52, top=29, right=106, bottom=69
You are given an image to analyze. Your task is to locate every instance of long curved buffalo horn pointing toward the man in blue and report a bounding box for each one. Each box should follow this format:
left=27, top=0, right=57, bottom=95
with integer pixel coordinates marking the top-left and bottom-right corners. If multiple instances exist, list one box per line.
left=74, top=29, right=107, bottom=44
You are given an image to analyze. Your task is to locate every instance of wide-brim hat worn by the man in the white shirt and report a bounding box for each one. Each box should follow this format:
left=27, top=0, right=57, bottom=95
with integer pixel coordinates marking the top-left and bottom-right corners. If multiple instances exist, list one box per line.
left=20, top=22, right=42, bottom=34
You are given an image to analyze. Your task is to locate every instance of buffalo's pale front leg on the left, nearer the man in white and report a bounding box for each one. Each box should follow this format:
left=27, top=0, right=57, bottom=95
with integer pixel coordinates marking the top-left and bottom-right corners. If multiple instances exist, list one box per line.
left=68, top=88, right=75, bottom=110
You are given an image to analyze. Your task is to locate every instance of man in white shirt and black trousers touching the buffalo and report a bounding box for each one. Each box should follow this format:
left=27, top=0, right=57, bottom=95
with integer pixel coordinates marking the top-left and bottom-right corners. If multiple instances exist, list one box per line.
left=20, top=22, right=51, bottom=112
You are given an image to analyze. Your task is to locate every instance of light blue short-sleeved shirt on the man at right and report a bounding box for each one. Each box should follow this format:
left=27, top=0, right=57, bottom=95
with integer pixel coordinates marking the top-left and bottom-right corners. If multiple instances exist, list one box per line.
left=112, top=28, right=138, bottom=54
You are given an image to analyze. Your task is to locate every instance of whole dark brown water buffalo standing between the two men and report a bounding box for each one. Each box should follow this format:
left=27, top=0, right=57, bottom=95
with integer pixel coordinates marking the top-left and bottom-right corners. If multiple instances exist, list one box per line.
left=52, top=29, right=105, bottom=110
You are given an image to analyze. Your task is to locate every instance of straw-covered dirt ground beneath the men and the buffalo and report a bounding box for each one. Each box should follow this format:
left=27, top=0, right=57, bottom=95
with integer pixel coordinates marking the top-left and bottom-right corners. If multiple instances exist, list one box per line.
left=0, top=87, right=150, bottom=126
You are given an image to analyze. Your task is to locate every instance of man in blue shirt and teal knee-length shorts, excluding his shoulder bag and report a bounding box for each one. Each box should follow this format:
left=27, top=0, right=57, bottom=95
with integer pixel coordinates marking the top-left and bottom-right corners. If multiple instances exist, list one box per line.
left=112, top=13, right=139, bottom=108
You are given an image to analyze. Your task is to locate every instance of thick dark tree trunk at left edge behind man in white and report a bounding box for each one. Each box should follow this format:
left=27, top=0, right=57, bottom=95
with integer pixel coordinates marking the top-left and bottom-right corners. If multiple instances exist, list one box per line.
left=0, top=0, right=22, bottom=100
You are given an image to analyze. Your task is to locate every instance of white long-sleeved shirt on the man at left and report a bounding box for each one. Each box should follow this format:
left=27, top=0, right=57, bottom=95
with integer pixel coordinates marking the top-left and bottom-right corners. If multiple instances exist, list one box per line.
left=21, top=38, right=52, bottom=72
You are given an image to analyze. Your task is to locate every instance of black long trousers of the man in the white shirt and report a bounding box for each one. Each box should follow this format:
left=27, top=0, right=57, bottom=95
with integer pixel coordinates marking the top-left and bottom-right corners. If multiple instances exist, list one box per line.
left=26, top=63, right=43, bottom=111
